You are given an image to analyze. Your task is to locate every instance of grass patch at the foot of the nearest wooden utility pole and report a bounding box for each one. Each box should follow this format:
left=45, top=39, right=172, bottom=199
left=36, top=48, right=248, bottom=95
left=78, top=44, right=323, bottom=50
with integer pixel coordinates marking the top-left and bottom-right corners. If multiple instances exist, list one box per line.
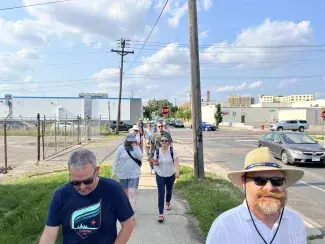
left=175, top=166, right=244, bottom=238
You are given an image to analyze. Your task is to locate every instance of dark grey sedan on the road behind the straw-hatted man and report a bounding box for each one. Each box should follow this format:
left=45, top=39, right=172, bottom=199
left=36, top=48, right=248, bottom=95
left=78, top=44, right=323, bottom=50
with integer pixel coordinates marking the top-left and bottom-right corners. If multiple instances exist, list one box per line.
left=258, top=131, right=325, bottom=164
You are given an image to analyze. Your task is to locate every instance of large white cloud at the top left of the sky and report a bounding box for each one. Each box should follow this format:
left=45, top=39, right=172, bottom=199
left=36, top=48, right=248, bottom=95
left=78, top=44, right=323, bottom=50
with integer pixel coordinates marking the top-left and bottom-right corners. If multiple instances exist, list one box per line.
left=0, top=0, right=153, bottom=47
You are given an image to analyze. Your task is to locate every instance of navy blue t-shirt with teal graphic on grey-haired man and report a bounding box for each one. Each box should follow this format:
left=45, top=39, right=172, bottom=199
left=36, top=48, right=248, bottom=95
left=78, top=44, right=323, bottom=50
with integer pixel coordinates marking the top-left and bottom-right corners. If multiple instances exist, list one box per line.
left=46, top=177, right=134, bottom=244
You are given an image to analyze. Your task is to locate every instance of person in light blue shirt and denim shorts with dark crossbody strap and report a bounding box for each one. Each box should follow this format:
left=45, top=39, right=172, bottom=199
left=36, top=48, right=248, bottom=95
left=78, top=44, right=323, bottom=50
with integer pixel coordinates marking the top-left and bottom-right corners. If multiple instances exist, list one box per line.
left=112, top=133, right=143, bottom=214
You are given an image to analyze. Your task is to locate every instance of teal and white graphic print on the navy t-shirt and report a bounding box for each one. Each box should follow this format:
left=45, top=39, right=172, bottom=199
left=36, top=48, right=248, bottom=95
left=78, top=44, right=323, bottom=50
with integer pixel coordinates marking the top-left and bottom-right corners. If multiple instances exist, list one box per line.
left=71, top=200, right=102, bottom=239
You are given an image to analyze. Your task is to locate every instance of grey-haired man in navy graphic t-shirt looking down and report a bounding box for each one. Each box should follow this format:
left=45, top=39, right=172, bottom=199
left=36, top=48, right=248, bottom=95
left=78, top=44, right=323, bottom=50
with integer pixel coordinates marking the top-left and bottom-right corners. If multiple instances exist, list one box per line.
left=39, top=149, right=134, bottom=244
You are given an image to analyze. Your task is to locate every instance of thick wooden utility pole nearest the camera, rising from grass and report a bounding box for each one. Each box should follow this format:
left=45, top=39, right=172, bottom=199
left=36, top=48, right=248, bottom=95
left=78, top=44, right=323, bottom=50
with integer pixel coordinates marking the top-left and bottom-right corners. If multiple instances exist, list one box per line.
left=188, top=0, right=204, bottom=179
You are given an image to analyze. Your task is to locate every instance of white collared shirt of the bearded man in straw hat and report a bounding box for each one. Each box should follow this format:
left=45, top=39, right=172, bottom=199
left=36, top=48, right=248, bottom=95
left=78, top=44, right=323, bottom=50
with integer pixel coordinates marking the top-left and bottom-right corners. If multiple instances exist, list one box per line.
left=206, top=201, right=307, bottom=244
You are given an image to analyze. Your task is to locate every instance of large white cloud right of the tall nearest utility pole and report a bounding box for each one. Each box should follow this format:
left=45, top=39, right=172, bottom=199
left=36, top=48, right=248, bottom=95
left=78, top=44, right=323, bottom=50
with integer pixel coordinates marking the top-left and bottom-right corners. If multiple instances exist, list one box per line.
left=200, top=19, right=313, bottom=67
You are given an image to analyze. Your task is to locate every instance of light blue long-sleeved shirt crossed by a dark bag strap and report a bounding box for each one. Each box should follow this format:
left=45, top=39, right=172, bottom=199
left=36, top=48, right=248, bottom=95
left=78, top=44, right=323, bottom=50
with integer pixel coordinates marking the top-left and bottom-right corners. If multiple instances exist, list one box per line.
left=112, top=145, right=143, bottom=179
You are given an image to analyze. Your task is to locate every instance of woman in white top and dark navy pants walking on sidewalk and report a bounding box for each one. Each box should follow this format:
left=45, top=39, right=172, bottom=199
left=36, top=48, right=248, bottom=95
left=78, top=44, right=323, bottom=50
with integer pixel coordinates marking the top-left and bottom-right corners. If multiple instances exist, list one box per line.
left=153, top=136, right=179, bottom=223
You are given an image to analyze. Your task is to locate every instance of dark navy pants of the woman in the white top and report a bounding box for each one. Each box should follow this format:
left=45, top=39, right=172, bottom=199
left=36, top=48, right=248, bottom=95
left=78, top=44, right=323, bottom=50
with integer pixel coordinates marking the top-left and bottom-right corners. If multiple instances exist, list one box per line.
left=156, top=173, right=175, bottom=214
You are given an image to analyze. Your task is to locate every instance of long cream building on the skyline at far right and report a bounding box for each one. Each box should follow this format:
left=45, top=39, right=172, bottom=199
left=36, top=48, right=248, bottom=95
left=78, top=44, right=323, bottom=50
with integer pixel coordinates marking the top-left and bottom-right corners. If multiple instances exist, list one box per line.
left=258, top=94, right=315, bottom=103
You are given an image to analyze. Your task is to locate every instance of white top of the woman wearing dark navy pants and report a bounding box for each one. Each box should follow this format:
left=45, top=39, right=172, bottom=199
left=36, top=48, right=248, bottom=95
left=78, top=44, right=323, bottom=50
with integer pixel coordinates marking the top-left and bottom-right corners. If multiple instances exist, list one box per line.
left=153, top=147, right=178, bottom=177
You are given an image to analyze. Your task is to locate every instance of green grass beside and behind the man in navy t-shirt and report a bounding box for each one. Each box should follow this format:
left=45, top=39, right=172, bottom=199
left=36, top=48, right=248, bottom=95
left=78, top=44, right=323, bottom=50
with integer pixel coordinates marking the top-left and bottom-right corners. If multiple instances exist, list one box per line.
left=0, top=166, right=111, bottom=244
